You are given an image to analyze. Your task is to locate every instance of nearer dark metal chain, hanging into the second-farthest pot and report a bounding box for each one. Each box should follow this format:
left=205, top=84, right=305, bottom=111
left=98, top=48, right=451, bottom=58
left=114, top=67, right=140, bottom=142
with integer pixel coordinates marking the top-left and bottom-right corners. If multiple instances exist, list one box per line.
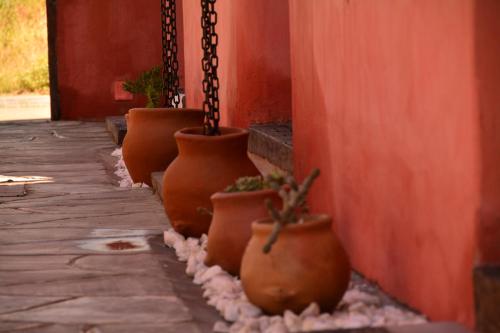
left=201, top=0, right=220, bottom=135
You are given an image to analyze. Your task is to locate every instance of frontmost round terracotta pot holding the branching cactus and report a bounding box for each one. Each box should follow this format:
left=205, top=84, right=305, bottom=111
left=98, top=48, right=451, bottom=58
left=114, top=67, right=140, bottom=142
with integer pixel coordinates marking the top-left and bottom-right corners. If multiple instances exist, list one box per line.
left=241, top=215, right=350, bottom=314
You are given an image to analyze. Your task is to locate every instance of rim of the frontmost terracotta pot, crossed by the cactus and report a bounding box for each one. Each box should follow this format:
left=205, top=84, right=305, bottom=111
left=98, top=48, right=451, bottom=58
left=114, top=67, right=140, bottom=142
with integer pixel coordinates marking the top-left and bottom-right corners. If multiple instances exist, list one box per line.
left=252, top=214, right=332, bottom=234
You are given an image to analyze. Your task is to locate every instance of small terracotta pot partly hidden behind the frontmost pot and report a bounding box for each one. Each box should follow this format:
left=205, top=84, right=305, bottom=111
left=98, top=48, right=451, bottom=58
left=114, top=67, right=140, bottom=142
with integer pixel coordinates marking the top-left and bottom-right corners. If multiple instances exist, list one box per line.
left=205, top=190, right=281, bottom=275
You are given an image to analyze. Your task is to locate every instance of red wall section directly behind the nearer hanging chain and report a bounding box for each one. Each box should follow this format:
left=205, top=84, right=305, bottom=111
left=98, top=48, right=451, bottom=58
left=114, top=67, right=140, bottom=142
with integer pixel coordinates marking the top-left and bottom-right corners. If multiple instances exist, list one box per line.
left=183, top=0, right=291, bottom=127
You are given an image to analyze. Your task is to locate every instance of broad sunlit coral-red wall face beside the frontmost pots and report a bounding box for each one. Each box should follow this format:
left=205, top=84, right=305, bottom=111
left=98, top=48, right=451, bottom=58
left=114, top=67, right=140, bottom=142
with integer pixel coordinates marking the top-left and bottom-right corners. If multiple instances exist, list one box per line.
left=290, top=0, right=480, bottom=326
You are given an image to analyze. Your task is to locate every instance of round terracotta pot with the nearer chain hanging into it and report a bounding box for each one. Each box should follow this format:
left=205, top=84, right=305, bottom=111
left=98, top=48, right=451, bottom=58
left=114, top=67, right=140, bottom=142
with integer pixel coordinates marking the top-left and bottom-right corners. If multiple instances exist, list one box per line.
left=163, top=127, right=259, bottom=237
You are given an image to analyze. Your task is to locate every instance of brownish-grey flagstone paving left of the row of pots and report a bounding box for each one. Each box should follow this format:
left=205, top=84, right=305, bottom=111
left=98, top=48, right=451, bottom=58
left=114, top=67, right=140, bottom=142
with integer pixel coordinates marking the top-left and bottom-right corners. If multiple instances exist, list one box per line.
left=0, top=121, right=219, bottom=333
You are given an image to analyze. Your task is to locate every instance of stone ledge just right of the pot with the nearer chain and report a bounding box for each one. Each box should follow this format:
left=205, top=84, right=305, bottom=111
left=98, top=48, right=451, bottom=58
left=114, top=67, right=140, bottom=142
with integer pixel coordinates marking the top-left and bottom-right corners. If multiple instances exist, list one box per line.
left=248, top=123, right=293, bottom=173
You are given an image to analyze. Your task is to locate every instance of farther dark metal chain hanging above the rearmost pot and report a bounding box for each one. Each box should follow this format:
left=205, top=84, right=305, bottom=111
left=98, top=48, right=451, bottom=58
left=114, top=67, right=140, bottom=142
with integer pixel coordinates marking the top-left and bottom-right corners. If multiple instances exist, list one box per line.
left=161, top=0, right=180, bottom=108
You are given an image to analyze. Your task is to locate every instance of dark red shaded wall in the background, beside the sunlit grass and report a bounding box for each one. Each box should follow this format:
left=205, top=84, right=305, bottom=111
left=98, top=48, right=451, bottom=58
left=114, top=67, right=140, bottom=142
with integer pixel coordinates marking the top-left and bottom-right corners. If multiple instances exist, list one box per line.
left=56, top=0, right=182, bottom=120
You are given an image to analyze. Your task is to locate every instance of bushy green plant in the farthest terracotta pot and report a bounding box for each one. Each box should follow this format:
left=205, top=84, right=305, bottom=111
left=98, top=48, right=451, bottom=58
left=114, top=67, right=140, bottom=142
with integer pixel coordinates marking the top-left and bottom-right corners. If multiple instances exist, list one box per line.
left=123, top=66, right=163, bottom=108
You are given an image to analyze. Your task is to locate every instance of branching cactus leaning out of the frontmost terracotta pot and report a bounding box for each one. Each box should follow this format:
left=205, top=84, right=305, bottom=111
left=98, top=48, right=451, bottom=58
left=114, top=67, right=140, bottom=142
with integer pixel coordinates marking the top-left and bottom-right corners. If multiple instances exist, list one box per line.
left=262, top=169, right=319, bottom=253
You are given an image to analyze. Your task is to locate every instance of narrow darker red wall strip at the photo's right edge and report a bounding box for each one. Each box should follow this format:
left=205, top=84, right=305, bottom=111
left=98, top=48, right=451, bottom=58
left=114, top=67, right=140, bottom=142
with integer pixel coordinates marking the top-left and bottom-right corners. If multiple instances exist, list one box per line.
left=475, top=0, right=500, bottom=266
